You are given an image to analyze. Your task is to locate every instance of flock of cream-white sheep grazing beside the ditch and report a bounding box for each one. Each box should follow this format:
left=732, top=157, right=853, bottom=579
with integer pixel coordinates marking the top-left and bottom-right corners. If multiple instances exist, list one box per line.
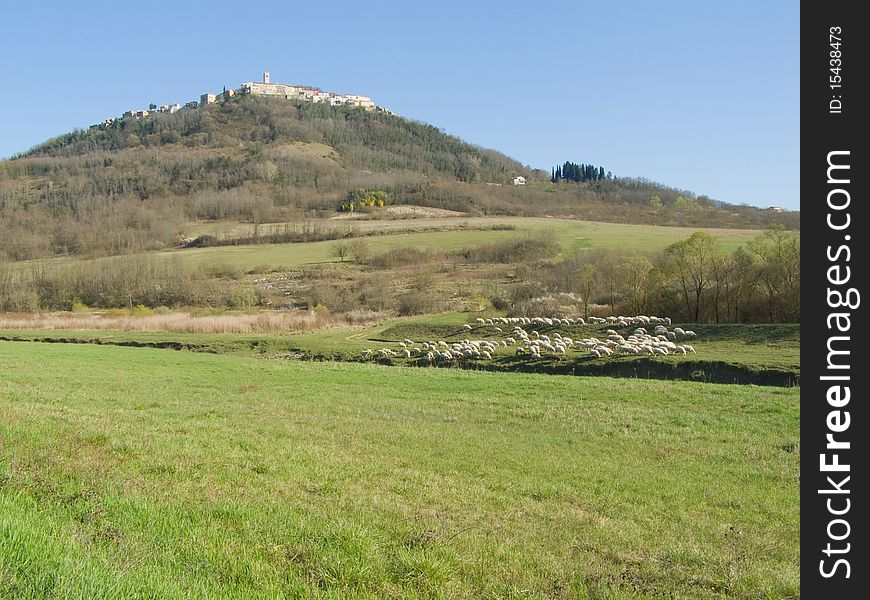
left=362, top=315, right=696, bottom=364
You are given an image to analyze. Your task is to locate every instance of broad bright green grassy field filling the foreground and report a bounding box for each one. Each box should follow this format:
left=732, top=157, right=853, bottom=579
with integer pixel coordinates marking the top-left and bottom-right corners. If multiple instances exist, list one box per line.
left=0, top=342, right=800, bottom=598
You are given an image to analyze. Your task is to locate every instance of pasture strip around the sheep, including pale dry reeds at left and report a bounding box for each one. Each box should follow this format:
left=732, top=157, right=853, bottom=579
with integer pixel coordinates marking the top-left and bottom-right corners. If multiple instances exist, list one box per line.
left=0, top=311, right=800, bottom=385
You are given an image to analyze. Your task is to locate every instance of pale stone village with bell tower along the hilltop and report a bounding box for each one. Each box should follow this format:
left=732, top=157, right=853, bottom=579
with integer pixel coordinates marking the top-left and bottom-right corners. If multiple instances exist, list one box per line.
left=90, top=71, right=390, bottom=129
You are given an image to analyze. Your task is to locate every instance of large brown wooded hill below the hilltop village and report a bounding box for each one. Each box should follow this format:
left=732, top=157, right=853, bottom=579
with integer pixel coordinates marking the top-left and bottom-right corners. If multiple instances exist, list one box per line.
left=0, top=97, right=799, bottom=260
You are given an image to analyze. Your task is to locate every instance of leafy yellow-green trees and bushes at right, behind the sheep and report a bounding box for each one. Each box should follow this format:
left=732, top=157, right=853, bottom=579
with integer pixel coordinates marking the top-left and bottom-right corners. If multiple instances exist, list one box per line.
left=508, top=227, right=800, bottom=323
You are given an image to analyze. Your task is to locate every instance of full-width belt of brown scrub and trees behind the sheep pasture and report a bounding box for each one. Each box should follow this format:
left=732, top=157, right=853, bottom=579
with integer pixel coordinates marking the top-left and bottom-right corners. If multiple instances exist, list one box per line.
left=0, top=228, right=800, bottom=323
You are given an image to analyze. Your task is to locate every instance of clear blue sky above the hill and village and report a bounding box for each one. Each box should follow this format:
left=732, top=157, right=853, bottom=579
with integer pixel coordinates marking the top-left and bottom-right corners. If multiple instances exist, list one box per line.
left=0, top=0, right=800, bottom=209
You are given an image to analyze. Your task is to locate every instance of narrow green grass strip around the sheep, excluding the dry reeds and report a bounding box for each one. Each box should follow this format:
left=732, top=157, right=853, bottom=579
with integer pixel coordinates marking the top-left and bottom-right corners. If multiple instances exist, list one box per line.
left=0, top=313, right=800, bottom=385
